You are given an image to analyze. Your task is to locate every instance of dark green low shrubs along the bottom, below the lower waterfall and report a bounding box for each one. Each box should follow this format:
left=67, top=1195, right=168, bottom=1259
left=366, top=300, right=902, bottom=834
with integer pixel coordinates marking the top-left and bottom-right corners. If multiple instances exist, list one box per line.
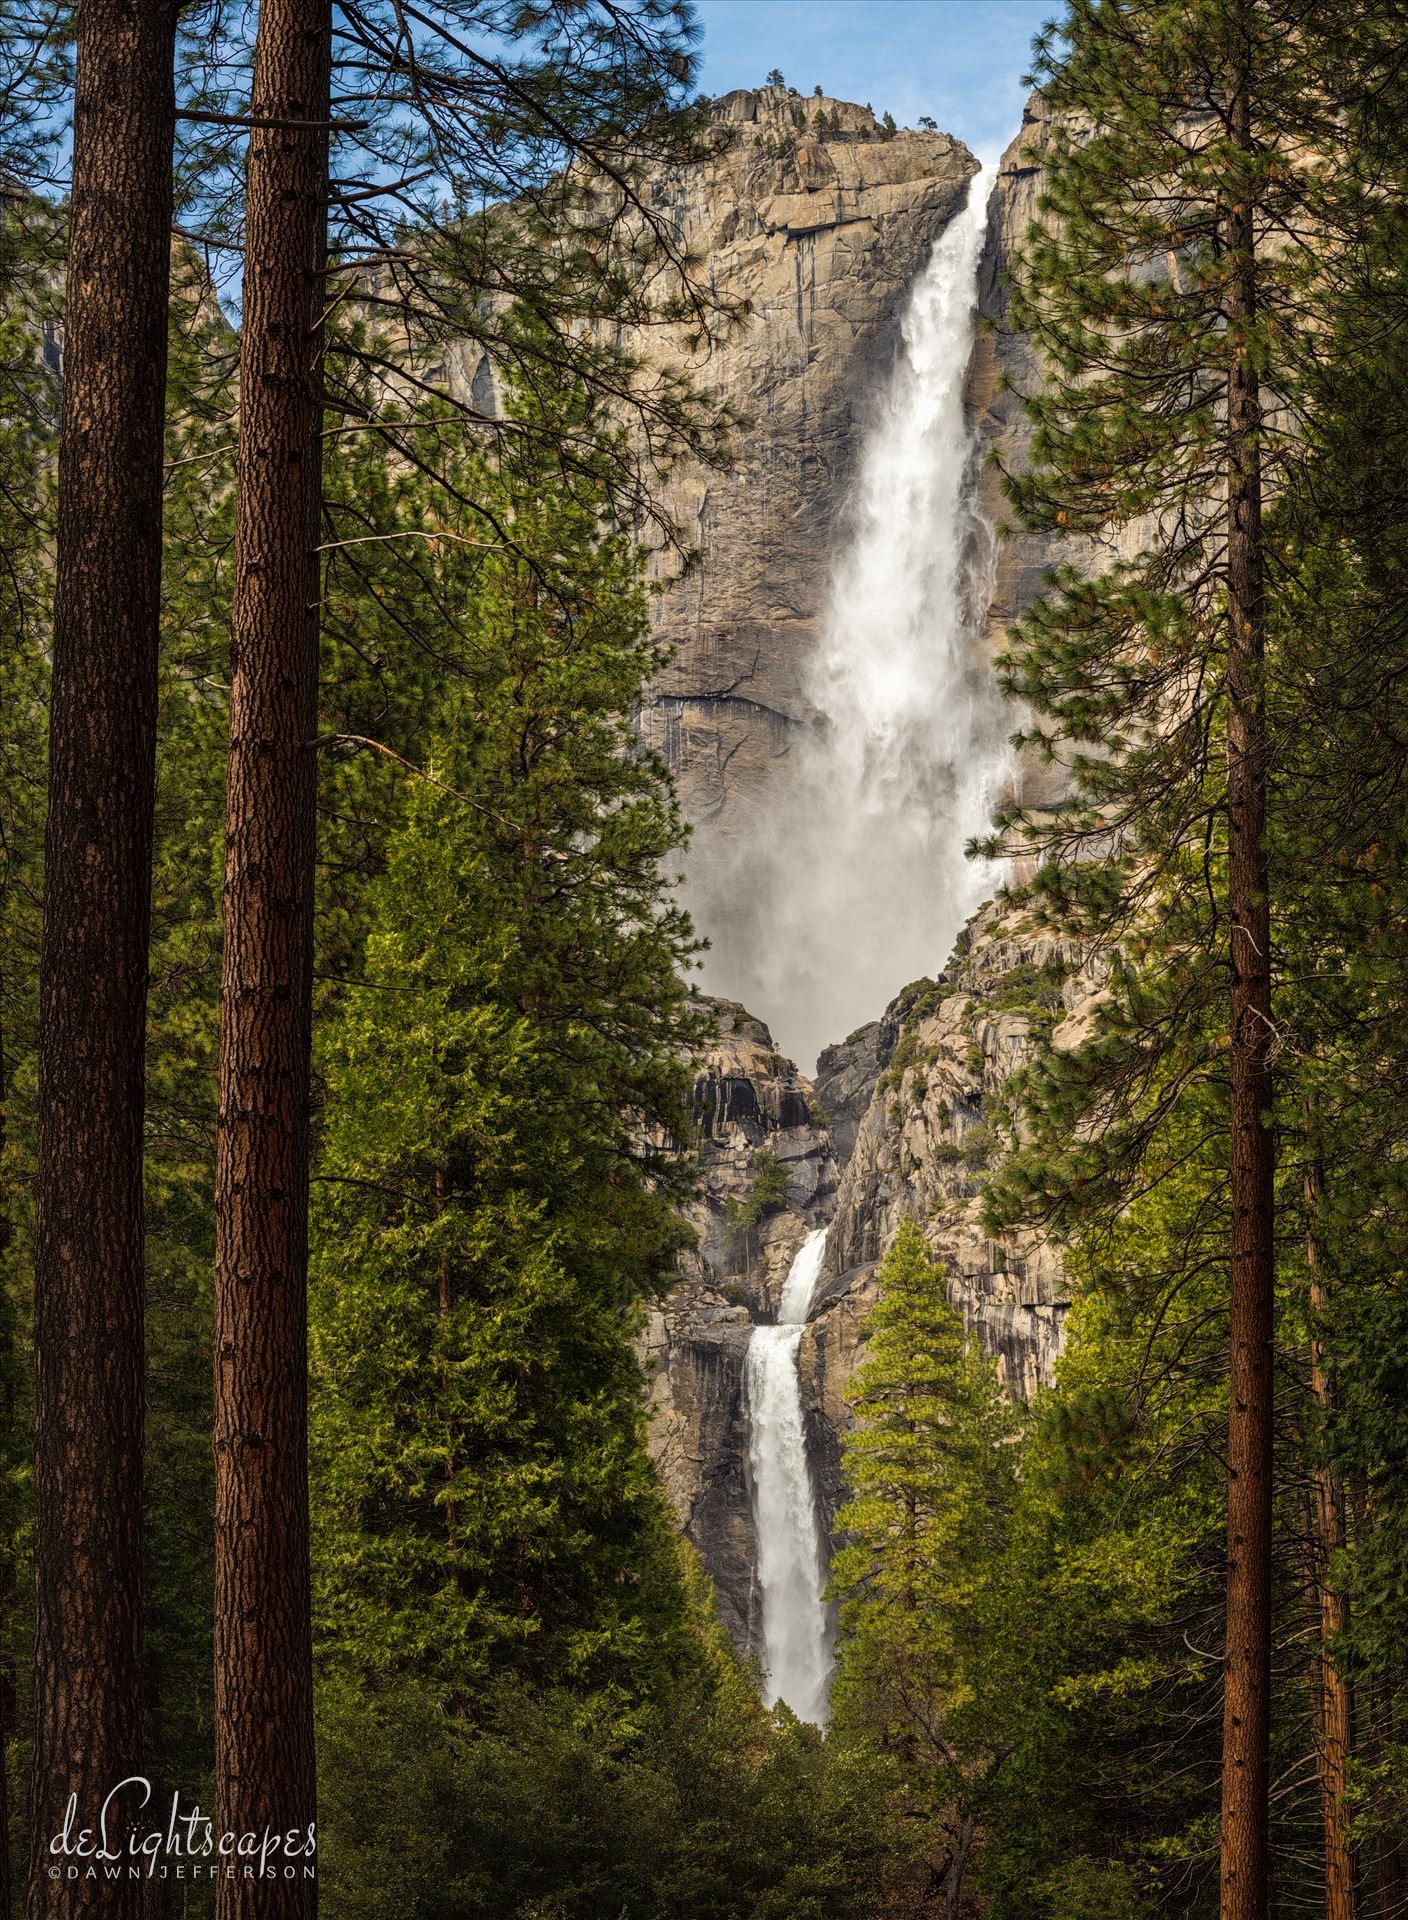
left=319, top=1693, right=899, bottom=1920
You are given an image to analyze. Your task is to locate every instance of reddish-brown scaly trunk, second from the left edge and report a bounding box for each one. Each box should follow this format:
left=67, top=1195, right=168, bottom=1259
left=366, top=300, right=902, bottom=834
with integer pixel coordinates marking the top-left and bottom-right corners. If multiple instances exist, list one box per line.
left=215, top=0, right=332, bottom=1920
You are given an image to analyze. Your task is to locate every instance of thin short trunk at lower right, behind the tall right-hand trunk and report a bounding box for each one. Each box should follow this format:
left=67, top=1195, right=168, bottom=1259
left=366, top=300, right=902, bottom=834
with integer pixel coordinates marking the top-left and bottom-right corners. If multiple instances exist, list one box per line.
left=1306, top=1158, right=1354, bottom=1920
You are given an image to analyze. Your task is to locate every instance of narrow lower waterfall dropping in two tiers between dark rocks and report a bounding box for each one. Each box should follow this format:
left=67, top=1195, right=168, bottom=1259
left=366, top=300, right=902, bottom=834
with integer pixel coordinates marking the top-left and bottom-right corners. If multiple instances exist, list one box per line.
left=743, top=1227, right=830, bottom=1726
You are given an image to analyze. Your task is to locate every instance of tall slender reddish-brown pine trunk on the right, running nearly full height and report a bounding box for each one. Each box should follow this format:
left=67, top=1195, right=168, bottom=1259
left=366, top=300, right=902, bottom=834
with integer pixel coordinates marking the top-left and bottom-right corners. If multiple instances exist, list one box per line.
left=1222, top=52, right=1275, bottom=1920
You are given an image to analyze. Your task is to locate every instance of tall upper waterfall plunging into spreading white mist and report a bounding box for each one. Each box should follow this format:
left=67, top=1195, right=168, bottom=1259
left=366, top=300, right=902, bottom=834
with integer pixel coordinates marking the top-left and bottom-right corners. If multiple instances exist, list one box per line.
left=695, top=169, right=1010, bottom=1066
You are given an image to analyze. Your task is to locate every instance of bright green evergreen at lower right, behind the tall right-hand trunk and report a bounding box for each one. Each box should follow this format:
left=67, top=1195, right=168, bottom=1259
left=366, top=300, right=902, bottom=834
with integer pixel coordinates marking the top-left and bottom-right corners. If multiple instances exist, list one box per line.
left=982, top=1089, right=1320, bottom=1916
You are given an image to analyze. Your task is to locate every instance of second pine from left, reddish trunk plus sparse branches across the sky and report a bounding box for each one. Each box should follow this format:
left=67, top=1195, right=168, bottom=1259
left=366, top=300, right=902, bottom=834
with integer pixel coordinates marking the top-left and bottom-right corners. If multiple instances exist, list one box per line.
left=215, top=0, right=729, bottom=1889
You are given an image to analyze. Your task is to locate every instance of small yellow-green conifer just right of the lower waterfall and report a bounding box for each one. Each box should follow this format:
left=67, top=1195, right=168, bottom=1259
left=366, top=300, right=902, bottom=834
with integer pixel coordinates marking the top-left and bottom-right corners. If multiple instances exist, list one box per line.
left=832, top=1219, right=1018, bottom=1920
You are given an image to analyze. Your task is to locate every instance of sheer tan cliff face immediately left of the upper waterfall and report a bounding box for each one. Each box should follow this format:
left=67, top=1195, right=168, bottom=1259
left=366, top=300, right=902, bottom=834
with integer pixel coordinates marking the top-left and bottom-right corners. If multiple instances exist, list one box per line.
left=642, top=86, right=978, bottom=860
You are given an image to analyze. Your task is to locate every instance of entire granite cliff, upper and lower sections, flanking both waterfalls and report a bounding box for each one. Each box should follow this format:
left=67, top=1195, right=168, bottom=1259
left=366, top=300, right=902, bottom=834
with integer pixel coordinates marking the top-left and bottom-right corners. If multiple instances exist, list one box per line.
left=642, top=88, right=1099, bottom=1651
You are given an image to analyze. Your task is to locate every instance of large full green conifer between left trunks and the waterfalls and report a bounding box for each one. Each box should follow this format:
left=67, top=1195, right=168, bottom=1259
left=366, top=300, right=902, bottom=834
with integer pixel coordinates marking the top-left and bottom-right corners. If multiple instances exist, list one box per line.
left=313, top=366, right=703, bottom=1713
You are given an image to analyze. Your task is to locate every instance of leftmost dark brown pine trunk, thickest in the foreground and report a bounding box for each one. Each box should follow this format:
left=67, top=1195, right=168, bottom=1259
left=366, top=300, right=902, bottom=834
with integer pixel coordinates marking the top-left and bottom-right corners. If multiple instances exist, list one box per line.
left=29, top=0, right=177, bottom=1920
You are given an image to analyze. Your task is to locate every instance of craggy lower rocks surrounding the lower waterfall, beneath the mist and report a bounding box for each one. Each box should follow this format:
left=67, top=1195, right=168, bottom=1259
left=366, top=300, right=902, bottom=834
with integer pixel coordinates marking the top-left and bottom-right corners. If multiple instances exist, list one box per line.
left=645, top=910, right=1103, bottom=1653
